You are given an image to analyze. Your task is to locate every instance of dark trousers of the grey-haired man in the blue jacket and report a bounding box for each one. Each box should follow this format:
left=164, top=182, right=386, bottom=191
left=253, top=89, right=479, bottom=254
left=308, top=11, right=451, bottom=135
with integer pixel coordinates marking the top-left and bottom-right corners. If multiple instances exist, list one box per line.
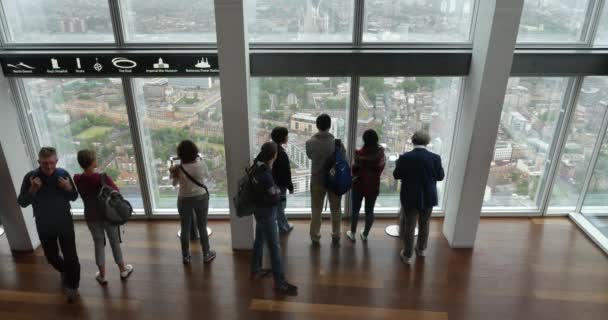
left=399, top=207, right=433, bottom=257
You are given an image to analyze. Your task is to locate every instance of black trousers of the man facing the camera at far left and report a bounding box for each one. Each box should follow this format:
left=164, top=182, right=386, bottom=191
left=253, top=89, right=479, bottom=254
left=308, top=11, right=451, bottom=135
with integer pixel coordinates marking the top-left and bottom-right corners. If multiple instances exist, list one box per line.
left=37, top=221, right=80, bottom=289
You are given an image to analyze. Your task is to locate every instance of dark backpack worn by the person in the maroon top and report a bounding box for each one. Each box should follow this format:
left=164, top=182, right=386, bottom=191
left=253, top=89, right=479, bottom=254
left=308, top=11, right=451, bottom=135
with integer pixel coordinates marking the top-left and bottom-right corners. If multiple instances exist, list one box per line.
left=97, top=173, right=133, bottom=225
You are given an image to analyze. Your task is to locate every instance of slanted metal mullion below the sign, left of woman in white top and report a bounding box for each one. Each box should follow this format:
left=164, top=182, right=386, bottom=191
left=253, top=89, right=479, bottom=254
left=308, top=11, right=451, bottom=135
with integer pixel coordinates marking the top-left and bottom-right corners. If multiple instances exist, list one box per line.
left=122, top=77, right=154, bottom=218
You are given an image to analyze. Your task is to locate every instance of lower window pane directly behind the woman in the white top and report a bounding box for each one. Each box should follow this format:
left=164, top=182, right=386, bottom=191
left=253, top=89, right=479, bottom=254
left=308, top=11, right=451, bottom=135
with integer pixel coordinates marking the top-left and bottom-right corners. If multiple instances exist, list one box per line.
left=133, top=77, right=228, bottom=213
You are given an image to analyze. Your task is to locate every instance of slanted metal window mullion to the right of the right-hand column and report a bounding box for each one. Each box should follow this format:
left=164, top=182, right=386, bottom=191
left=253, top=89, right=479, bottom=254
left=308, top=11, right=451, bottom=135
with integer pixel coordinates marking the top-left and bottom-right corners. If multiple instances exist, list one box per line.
left=536, top=77, right=584, bottom=216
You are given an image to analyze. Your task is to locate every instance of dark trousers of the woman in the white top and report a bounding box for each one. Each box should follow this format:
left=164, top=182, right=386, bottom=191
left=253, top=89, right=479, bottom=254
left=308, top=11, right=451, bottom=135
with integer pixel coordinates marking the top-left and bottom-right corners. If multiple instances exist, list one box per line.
left=177, top=194, right=209, bottom=257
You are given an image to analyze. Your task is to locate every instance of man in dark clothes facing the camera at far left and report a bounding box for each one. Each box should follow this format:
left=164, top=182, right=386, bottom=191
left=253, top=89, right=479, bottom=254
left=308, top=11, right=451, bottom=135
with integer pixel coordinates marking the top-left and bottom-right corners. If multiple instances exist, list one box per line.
left=17, top=147, right=80, bottom=303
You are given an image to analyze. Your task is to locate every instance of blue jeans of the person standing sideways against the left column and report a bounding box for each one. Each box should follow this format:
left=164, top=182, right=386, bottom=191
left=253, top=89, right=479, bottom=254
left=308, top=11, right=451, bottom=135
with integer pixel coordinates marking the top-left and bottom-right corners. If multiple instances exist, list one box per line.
left=251, top=206, right=285, bottom=286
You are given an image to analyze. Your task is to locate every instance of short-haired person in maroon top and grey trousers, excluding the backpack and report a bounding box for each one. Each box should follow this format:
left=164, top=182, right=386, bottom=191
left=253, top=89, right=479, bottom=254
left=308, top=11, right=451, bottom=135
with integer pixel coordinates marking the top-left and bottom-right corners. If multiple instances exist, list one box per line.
left=74, top=149, right=133, bottom=285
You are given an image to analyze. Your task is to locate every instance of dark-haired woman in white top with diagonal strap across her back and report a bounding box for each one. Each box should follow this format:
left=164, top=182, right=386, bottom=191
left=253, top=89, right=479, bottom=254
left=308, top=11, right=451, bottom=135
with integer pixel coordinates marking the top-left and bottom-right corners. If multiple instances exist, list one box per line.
left=169, top=140, right=216, bottom=264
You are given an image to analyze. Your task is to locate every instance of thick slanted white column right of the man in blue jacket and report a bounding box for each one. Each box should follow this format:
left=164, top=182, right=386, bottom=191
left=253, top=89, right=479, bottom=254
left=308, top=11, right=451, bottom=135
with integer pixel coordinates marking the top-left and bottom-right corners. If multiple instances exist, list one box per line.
left=443, top=0, right=523, bottom=248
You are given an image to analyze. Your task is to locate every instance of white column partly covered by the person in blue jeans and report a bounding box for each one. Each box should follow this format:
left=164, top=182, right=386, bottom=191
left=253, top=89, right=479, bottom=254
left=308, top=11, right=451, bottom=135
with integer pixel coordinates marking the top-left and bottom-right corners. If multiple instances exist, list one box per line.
left=214, top=0, right=253, bottom=249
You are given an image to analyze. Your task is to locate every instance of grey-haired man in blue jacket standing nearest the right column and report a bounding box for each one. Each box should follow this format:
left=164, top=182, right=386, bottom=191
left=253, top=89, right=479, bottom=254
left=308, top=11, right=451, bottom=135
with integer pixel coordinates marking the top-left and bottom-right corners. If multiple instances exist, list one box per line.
left=393, top=131, right=445, bottom=263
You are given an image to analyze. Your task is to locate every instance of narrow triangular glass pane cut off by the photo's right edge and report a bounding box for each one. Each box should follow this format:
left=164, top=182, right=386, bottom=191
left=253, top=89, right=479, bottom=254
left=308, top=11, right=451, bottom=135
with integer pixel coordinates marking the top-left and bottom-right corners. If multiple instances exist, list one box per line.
left=582, top=129, right=608, bottom=236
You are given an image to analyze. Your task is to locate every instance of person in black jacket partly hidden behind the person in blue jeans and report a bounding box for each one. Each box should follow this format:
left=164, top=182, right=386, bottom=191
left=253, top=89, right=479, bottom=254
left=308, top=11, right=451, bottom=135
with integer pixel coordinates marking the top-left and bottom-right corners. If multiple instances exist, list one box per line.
left=270, top=127, right=293, bottom=233
